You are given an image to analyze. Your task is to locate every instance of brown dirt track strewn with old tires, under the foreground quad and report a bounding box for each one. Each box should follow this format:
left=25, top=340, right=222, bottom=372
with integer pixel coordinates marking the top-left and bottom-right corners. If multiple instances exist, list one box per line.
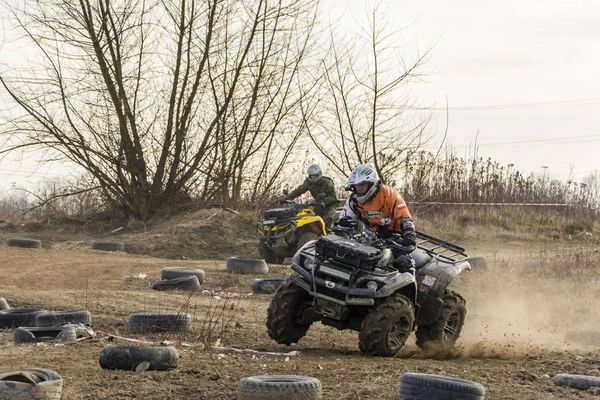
left=0, top=227, right=600, bottom=400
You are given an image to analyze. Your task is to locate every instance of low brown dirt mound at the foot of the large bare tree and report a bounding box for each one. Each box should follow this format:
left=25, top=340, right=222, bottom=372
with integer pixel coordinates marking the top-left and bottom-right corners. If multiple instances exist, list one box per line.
left=0, top=208, right=258, bottom=260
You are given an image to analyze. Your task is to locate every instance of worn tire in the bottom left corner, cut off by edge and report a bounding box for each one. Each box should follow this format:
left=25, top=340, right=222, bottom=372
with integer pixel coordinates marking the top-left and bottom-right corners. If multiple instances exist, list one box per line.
left=0, top=368, right=63, bottom=400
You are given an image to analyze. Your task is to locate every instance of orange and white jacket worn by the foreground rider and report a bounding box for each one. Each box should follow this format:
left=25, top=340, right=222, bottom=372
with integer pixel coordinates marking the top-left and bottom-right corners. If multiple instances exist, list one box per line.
left=340, top=183, right=415, bottom=237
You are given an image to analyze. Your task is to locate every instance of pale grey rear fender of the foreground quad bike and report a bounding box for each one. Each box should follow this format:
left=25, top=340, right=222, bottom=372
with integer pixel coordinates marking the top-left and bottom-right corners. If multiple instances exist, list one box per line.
left=417, top=259, right=471, bottom=297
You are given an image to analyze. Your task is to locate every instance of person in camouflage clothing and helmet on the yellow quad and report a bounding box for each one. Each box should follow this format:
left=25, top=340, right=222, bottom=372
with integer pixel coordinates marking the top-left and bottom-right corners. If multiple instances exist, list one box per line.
left=284, top=164, right=339, bottom=226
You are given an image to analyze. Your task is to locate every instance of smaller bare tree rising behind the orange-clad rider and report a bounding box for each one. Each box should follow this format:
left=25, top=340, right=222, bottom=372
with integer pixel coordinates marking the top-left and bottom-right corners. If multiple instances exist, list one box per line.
left=303, top=3, right=431, bottom=180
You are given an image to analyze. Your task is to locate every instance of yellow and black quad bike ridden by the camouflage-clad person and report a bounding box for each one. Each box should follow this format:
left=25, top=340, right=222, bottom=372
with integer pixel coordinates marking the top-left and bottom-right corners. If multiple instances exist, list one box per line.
left=258, top=200, right=326, bottom=264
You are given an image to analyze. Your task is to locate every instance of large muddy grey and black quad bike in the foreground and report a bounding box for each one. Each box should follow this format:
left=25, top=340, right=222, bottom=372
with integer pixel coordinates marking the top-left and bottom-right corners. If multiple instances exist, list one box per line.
left=266, top=223, right=471, bottom=357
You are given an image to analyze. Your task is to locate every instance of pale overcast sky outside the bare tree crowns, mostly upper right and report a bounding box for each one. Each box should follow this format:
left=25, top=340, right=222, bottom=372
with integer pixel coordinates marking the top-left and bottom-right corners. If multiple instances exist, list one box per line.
left=0, top=0, right=600, bottom=191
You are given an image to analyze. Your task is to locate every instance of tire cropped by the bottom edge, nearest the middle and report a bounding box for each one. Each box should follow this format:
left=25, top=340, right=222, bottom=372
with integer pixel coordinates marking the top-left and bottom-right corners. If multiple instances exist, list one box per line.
left=236, top=375, right=322, bottom=400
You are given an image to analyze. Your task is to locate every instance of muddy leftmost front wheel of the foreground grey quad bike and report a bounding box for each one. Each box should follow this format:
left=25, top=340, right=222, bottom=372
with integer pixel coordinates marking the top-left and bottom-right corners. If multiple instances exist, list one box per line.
left=266, top=280, right=312, bottom=345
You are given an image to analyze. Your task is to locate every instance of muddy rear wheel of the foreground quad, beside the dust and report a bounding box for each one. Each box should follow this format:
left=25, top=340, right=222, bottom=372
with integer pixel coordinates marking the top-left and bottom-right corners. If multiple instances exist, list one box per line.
left=416, top=291, right=467, bottom=350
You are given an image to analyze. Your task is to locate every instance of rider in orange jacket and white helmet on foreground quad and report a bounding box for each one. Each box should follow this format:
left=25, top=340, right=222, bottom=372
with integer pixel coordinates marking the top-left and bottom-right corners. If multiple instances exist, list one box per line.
left=338, top=164, right=417, bottom=268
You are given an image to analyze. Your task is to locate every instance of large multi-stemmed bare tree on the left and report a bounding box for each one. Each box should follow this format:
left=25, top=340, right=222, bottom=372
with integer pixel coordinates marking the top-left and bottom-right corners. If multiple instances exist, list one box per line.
left=0, top=0, right=318, bottom=219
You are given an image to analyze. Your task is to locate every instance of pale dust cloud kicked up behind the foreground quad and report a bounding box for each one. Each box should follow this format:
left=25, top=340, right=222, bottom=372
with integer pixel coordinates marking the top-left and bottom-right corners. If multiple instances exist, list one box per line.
left=451, top=244, right=600, bottom=358
